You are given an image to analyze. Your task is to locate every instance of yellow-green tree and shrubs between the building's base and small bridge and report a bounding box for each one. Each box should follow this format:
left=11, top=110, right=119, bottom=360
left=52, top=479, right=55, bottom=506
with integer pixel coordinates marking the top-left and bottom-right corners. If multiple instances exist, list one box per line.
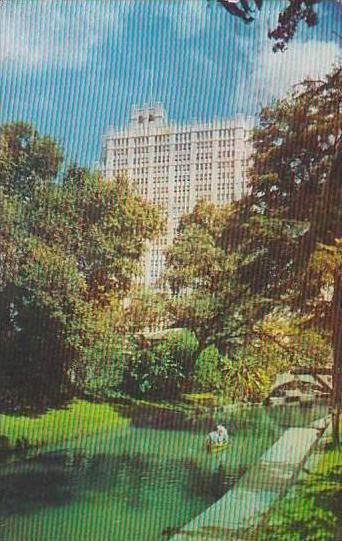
left=166, top=202, right=331, bottom=400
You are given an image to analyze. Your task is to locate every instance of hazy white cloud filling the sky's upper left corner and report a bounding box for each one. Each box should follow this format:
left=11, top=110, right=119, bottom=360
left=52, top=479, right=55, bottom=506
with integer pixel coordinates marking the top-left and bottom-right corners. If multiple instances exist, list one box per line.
left=0, top=0, right=131, bottom=70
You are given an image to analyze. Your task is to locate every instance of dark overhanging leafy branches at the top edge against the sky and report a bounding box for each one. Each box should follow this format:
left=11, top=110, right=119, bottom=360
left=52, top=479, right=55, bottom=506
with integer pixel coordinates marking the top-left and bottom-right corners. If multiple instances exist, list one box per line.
left=217, top=0, right=321, bottom=52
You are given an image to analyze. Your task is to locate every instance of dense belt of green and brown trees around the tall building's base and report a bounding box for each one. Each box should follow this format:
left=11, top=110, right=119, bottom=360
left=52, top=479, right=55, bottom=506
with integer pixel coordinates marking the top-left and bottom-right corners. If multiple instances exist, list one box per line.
left=0, top=68, right=342, bottom=446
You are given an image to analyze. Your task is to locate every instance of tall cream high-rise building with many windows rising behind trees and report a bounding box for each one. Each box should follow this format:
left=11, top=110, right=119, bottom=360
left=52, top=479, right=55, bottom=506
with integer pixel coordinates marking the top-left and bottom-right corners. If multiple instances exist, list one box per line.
left=101, top=105, right=253, bottom=287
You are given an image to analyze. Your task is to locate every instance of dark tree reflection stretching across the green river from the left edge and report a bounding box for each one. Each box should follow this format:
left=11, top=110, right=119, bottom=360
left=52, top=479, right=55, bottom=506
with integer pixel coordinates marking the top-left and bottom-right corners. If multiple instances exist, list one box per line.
left=0, top=451, right=225, bottom=515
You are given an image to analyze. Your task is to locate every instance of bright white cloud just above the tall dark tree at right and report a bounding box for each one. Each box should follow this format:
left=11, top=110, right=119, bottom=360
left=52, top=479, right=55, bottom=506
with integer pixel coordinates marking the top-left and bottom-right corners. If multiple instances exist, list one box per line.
left=251, top=41, right=341, bottom=102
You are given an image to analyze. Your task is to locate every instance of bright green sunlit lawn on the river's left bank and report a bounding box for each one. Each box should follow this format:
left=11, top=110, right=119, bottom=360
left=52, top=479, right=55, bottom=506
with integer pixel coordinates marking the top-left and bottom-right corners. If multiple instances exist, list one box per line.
left=0, top=400, right=129, bottom=447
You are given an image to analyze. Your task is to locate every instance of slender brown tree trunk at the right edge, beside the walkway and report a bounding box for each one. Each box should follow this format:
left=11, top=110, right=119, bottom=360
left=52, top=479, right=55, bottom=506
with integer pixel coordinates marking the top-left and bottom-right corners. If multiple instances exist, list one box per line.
left=331, top=268, right=342, bottom=446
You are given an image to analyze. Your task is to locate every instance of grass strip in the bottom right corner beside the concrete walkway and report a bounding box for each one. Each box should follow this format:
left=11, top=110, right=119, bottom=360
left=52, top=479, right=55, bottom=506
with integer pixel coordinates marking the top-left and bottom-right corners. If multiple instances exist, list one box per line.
left=243, top=426, right=342, bottom=541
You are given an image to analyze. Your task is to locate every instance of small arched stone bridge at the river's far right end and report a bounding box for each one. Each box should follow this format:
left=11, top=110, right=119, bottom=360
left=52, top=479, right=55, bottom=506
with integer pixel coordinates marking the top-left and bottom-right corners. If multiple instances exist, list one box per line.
left=269, top=367, right=332, bottom=398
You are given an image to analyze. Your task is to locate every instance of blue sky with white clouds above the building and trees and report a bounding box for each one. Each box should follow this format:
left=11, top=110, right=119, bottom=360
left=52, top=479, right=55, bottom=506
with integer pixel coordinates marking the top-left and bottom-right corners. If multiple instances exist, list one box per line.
left=0, top=0, right=342, bottom=167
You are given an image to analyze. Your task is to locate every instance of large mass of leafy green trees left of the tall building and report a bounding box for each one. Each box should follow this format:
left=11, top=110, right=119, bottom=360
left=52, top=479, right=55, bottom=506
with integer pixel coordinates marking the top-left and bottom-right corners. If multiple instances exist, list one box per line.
left=0, top=124, right=163, bottom=408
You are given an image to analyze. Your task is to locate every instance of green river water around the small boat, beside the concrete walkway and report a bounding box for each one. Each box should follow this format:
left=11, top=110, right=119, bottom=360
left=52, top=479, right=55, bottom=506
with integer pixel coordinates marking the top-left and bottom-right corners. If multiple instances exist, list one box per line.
left=0, top=406, right=326, bottom=541
